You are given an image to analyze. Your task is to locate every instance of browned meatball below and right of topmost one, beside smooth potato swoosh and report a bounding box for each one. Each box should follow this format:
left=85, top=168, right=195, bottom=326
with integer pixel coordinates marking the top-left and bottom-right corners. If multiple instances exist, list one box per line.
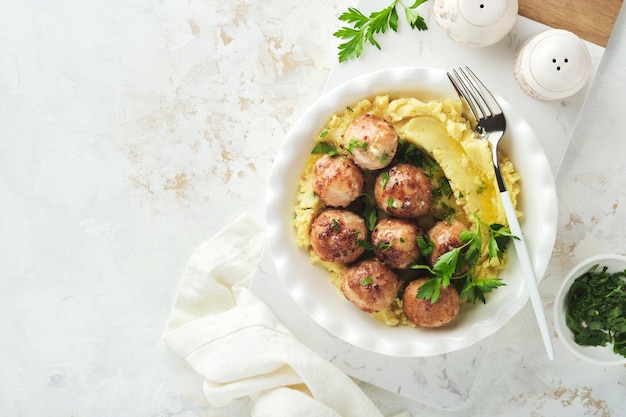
left=374, top=164, right=433, bottom=218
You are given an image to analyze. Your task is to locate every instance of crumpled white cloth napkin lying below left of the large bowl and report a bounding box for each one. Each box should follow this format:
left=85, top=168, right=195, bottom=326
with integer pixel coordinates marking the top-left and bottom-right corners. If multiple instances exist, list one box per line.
left=164, top=214, right=382, bottom=417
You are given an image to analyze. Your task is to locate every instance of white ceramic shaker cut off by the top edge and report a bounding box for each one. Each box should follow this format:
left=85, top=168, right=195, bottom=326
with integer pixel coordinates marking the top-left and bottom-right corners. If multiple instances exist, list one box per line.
left=434, top=0, right=519, bottom=47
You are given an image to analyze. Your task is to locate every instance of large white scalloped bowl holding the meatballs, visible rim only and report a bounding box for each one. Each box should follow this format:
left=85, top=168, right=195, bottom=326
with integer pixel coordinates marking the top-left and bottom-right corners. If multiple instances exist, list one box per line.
left=265, top=67, right=557, bottom=357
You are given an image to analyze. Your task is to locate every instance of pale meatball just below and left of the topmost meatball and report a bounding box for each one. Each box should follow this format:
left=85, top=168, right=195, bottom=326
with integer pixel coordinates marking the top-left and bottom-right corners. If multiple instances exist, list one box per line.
left=313, top=155, right=364, bottom=207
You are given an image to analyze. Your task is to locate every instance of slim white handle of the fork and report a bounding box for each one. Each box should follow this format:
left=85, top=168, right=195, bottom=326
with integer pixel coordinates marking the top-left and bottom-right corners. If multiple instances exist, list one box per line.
left=498, top=189, right=554, bottom=360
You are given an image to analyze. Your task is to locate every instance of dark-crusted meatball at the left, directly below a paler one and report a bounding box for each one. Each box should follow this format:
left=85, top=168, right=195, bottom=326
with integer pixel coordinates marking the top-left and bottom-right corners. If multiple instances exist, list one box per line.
left=310, top=209, right=367, bottom=263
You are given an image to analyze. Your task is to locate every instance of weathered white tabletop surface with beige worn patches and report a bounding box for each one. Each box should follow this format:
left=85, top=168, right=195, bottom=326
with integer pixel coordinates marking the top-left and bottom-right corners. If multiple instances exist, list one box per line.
left=0, top=0, right=626, bottom=417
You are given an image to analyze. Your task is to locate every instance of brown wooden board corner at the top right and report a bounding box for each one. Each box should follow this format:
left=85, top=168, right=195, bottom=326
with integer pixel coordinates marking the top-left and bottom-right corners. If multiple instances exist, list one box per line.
left=519, top=0, right=623, bottom=47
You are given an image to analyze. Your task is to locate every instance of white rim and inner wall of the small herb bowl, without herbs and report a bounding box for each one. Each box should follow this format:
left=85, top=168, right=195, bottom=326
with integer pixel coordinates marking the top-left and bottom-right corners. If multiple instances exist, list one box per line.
left=554, top=254, right=626, bottom=365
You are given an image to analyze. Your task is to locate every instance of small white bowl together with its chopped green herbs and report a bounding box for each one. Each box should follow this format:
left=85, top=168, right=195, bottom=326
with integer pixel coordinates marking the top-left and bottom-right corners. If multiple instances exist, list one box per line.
left=554, top=255, right=626, bottom=365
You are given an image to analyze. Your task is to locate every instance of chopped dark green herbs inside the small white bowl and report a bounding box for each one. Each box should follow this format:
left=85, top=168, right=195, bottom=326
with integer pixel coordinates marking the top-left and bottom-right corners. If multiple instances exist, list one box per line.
left=565, top=264, right=626, bottom=357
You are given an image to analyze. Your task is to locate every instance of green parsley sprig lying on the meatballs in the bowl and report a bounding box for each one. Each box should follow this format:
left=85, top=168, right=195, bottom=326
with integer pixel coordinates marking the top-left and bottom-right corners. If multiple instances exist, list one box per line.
left=411, top=215, right=517, bottom=304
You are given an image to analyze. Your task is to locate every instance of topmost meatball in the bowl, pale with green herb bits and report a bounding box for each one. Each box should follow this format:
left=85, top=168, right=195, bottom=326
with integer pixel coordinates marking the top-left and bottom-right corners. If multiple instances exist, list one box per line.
left=343, top=114, right=398, bottom=170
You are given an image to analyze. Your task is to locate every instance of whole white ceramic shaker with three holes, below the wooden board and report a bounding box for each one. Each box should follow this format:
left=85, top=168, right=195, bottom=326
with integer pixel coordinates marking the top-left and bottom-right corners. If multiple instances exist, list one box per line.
left=513, top=29, right=591, bottom=101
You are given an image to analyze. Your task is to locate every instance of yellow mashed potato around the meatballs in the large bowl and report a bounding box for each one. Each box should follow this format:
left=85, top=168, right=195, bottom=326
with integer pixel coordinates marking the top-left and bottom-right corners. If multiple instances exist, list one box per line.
left=294, top=95, right=521, bottom=326
